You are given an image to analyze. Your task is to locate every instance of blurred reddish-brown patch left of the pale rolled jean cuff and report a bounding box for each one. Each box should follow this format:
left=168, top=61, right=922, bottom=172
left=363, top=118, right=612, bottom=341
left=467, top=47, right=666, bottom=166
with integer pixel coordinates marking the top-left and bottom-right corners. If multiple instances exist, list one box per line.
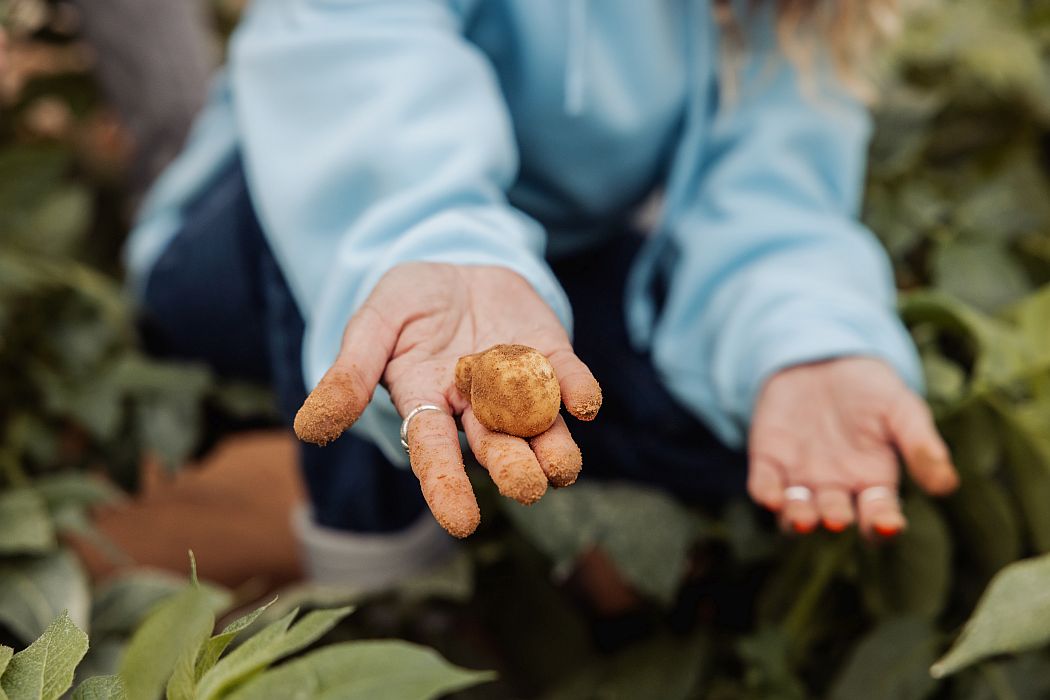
left=74, top=431, right=303, bottom=595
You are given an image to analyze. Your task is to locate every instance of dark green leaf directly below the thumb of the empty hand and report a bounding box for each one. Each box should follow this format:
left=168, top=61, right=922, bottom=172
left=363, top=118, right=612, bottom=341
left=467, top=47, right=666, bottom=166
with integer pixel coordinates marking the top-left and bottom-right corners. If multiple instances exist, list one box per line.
left=861, top=496, right=951, bottom=618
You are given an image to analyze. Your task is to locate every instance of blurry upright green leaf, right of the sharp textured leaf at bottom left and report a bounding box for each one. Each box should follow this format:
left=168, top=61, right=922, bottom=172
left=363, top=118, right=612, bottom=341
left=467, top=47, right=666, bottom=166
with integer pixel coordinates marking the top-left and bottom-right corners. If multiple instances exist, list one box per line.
left=120, top=585, right=230, bottom=698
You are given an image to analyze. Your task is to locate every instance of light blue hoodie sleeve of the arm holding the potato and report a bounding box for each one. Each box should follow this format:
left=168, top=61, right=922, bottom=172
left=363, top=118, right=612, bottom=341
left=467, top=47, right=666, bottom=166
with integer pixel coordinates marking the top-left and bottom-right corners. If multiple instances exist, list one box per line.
left=229, top=0, right=571, bottom=398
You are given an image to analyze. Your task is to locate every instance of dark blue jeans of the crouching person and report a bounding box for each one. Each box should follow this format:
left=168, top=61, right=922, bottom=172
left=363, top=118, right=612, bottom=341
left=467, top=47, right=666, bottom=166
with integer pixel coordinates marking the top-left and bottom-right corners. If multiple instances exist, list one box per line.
left=142, top=163, right=746, bottom=532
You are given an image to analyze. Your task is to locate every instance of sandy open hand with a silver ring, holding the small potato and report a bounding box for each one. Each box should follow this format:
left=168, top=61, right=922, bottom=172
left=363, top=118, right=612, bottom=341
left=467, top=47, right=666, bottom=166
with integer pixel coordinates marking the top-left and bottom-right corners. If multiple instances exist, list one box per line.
left=295, top=262, right=602, bottom=537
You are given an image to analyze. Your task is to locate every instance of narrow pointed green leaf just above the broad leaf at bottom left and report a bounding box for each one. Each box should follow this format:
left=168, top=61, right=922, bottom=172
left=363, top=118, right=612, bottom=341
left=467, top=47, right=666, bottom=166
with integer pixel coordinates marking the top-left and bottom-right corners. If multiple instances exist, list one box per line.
left=191, top=608, right=353, bottom=700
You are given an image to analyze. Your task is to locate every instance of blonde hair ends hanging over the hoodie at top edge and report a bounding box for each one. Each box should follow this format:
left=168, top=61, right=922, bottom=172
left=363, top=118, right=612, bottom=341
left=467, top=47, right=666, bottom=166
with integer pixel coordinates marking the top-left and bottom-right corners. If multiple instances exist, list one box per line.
left=714, top=0, right=900, bottom=100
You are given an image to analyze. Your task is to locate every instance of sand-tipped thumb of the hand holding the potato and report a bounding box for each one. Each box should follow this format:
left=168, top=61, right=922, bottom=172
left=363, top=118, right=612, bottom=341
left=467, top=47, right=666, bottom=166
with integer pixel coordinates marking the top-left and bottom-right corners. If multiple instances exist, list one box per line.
left=294, top=300, right=400, bottom=445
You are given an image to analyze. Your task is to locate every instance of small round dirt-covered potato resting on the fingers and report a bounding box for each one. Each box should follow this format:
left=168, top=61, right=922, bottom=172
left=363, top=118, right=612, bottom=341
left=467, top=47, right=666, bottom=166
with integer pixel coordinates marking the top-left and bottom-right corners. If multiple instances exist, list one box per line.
left=456, top=345, right=562, bottom=438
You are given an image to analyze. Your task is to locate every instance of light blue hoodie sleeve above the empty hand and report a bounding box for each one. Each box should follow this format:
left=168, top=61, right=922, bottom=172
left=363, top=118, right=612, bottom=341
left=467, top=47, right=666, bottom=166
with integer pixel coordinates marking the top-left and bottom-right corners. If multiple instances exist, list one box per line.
left=651, top=12, right=922, bottom=446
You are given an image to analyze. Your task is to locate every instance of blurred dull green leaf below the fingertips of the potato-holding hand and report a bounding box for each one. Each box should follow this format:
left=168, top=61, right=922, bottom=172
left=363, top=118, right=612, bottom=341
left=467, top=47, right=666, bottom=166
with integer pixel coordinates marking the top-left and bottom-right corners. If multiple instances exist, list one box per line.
left=503, top=482, right=698, bottom=603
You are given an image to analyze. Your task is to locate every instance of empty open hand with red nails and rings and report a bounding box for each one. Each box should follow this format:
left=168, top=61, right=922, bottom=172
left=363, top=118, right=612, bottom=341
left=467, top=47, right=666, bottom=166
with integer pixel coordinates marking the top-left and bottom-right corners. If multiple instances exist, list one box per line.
left=748, top=357, right=959, bottom=536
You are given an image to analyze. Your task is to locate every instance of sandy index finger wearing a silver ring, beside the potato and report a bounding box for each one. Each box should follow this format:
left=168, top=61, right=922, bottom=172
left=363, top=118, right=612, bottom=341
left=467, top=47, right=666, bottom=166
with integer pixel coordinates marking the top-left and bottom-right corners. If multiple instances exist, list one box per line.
left=407, top=410, right=481, bottom=538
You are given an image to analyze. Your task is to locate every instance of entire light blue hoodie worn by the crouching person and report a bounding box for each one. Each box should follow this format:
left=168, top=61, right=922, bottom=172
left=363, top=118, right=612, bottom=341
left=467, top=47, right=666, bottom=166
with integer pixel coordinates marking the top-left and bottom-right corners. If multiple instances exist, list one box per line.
left=128, top=0, right=921, bottom=464
